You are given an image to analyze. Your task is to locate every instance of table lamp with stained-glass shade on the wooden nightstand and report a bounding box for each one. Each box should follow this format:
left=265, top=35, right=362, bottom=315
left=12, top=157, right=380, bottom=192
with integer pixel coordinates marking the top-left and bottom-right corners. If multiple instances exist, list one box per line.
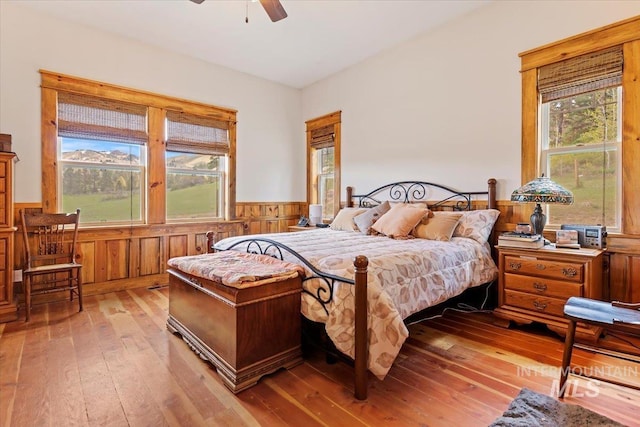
left=511, top=175, right=573, bottom=235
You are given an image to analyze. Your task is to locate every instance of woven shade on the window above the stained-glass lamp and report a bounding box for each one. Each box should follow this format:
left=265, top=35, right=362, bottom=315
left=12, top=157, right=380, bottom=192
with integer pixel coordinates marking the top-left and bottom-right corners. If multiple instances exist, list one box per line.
left=538, top=46, right=623, bottom=102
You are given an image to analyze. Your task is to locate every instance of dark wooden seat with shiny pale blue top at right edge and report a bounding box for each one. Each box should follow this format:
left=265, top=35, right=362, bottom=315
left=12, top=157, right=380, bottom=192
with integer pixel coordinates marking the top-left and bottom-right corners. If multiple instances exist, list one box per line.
left=558, top=297, right=640, bottom=397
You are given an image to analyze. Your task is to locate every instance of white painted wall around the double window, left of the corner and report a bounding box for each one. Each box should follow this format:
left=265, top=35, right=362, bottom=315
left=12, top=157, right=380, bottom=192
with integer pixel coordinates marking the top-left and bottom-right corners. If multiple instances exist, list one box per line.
left=0, top=1, right=306, bottom=202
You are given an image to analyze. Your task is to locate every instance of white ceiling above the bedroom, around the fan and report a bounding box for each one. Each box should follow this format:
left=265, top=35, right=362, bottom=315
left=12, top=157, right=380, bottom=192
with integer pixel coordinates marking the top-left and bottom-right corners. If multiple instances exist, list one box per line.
left=17, top=0, right=491, bottom=88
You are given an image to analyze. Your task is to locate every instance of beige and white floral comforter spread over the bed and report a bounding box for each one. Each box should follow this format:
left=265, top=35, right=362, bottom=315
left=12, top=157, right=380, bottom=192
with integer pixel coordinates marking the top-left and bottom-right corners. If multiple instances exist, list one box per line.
left=215, top=229, right=498, bottom=379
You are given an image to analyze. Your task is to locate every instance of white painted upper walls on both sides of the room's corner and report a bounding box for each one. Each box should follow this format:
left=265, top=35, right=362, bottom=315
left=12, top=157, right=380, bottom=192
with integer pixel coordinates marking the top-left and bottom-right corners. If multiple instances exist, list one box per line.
left=0, top=0, right=640, bottom=206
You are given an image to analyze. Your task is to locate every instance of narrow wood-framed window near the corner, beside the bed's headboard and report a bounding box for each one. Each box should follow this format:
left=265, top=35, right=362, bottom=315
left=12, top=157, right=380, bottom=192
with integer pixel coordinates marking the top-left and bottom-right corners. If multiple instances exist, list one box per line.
left=306, top=112, right=341, bottom=220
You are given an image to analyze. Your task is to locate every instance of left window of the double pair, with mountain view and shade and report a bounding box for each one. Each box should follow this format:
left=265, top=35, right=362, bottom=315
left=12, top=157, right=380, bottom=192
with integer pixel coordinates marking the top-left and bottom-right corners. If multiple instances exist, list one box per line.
left=58, top=92, right=147, bottom=224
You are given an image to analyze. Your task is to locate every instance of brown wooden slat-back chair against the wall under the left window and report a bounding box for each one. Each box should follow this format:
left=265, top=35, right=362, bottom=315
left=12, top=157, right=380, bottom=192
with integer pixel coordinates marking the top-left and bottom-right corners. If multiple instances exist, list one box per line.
left=20, top=209, right=82, bottom=322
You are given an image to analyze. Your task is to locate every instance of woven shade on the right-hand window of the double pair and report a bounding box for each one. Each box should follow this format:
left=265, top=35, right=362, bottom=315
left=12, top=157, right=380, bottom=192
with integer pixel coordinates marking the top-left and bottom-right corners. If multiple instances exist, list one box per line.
left=167, top=111, right=229, bottom=155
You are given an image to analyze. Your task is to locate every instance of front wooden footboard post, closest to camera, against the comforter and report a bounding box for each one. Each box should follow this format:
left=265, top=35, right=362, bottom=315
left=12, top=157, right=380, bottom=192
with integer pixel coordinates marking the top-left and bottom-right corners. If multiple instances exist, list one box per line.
left=353, top=255, right=369, bottom=400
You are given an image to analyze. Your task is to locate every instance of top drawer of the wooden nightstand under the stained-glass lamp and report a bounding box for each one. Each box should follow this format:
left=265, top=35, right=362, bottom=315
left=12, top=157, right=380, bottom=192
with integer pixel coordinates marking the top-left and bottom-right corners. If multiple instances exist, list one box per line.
left=504, top=256, right=584, bottom=283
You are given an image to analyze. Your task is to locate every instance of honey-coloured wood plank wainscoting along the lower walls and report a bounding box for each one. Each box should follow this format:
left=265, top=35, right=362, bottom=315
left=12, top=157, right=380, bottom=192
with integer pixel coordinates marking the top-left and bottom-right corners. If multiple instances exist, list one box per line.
left=15, top=201, right=640, bottom=302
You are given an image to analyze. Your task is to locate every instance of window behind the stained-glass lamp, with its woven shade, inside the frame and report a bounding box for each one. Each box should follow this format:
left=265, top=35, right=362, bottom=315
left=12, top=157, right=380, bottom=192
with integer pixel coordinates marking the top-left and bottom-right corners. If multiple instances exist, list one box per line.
left=538, top=46, right=622, bottom=231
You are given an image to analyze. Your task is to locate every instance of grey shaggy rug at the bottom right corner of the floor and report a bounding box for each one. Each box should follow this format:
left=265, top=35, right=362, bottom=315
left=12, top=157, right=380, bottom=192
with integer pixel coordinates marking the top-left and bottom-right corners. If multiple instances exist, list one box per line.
left=490, top=388, right=624, bottom=427
